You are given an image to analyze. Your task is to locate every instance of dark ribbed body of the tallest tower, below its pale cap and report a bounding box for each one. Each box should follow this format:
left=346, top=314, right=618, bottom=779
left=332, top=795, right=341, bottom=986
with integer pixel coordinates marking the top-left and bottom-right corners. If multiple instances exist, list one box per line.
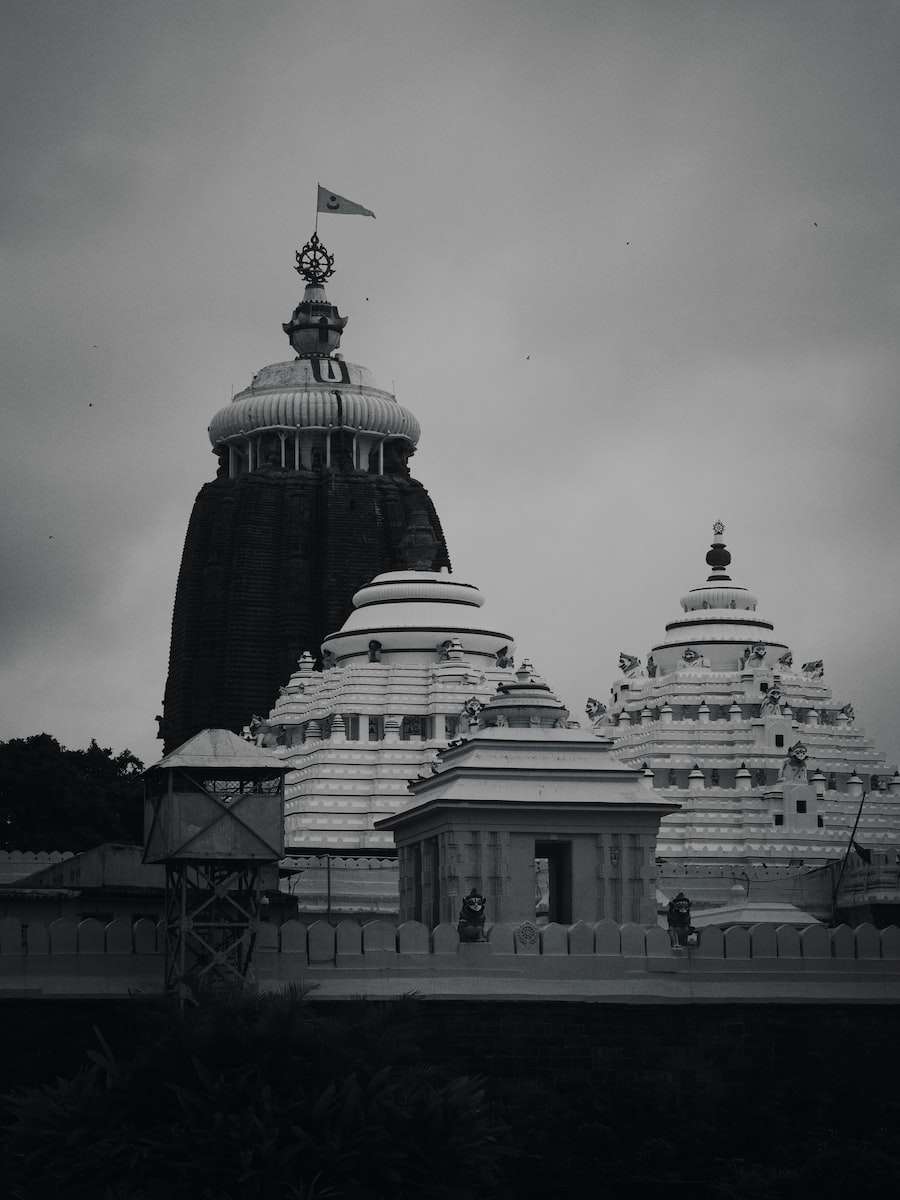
left=163, top=469, right=450, bottom=751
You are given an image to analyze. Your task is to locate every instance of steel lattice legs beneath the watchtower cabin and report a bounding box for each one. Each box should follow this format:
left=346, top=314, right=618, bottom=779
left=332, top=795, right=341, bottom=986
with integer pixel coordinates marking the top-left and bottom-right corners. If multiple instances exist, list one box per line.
left=166, top=859, right=263, bottom=1000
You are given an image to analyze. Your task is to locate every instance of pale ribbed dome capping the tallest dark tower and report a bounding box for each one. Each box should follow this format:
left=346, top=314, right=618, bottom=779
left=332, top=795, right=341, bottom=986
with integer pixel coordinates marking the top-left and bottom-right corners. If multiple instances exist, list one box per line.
left=209, top=359, right=421, bottom=445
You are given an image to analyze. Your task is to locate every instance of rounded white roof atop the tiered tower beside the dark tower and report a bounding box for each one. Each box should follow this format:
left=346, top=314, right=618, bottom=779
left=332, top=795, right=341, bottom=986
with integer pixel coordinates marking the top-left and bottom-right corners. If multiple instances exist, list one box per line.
left=322, top=571, right=514, bottom=662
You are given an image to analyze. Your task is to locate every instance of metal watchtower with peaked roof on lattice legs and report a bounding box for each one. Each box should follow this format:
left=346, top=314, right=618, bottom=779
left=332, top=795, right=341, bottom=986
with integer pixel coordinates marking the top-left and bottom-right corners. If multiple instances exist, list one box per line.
left=144, top=730, right=286, bottom=997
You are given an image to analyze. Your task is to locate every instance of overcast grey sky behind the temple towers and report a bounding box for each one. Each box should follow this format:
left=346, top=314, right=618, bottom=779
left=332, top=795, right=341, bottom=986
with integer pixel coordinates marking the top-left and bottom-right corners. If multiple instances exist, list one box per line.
left=0, top=0, right=900, bottom=762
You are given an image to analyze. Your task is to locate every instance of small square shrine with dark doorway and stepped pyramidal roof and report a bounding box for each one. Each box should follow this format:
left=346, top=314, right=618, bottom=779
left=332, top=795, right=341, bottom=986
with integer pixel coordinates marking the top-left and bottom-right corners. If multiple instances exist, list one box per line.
left=377, top=664, right=677, bottom=926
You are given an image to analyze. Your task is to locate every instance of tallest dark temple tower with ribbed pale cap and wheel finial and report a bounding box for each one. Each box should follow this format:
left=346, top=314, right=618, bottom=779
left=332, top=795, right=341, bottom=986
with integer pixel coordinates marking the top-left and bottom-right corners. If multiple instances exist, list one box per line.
left=160, top=234, right=450, bottom=751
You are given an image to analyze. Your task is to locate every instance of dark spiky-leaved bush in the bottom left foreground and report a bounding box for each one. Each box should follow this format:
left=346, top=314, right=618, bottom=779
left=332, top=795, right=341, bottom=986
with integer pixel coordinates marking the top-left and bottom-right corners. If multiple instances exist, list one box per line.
left=5, top=995, right=508, bottom=1200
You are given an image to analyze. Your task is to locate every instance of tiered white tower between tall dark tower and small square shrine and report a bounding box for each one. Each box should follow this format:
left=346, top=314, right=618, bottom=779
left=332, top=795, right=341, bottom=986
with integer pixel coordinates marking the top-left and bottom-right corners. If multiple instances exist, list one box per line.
left=256, top=561, right=514, bottom=856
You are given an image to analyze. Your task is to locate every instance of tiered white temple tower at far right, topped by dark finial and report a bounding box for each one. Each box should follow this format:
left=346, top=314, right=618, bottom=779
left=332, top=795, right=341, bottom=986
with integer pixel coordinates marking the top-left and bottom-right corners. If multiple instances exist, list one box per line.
left=600, top=521, right=900, bottom=902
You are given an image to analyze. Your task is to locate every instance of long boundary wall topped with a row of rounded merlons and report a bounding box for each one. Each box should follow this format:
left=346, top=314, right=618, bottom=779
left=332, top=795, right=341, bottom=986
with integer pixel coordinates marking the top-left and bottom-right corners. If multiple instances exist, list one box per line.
left=0, top=917, right=900, bottom=1003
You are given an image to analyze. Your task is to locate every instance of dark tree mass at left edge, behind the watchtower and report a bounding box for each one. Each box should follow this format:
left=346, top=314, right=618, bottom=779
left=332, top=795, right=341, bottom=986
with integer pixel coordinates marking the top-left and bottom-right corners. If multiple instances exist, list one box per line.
left=0, top=733, right=144, bottom=851
